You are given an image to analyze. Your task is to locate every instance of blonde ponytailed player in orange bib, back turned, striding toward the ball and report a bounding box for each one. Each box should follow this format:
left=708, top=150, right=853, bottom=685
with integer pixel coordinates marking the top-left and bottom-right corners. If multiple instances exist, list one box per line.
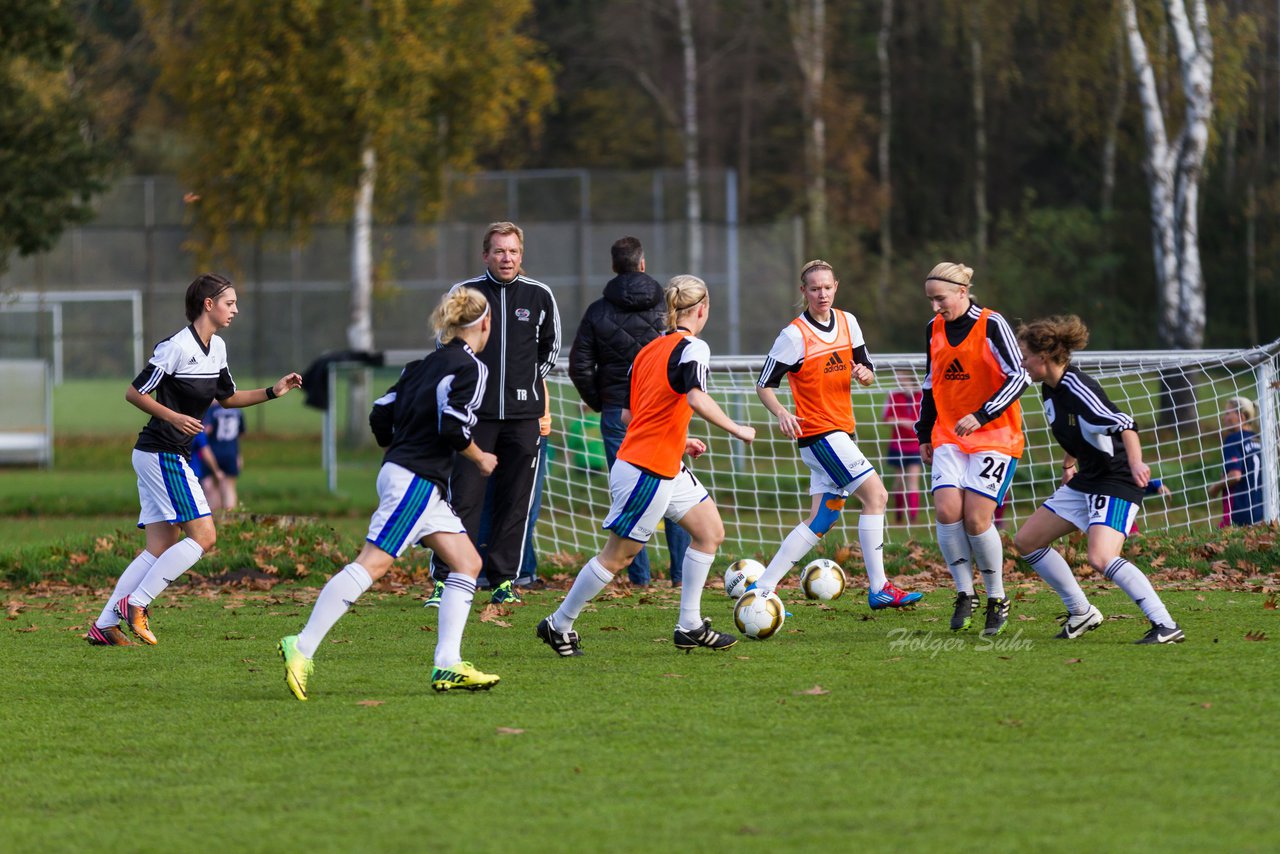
left=538, top=275, right=755, bottom=657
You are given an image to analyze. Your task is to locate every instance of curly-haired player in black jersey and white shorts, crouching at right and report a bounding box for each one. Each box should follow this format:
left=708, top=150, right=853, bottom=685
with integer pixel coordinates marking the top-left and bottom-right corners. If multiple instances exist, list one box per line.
left=1014, top=315, right=1184, bottom=644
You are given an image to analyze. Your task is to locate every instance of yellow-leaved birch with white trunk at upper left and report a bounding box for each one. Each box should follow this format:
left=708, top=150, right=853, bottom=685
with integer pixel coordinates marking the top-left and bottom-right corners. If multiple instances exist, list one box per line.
left=146, top=0, right=552, bottom=350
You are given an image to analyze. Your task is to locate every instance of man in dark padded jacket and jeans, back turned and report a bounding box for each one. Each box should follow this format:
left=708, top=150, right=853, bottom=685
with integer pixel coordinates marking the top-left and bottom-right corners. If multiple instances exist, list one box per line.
left=568, top=237, right=690, bottom=585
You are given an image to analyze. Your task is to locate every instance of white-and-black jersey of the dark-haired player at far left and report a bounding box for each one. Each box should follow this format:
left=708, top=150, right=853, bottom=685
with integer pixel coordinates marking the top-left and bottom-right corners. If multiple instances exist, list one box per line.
left=133, top=325, right=236, bottom=458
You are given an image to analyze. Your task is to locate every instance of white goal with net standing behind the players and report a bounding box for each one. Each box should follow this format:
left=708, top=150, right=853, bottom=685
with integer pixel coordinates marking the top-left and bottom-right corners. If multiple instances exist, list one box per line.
left=325, top=341, right=1280, bottom=566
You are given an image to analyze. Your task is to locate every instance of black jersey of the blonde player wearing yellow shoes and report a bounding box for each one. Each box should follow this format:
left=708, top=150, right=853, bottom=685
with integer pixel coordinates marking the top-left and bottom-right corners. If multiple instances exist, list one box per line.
left=369, top=338, right=489, bottom=489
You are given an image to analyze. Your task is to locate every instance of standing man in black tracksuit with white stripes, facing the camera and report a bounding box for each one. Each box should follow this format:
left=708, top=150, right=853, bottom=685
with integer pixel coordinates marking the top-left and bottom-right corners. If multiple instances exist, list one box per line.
left=434, top=223, right=561, bottom=602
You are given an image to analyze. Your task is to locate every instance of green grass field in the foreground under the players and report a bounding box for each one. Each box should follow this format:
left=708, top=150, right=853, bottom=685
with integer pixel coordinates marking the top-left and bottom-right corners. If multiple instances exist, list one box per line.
left=0, top=584, right=1280, bottom=851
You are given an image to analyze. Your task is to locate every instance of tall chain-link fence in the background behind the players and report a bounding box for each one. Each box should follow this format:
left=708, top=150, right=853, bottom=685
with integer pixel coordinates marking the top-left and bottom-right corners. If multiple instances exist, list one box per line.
left=0, top=169, right=803, bottom=378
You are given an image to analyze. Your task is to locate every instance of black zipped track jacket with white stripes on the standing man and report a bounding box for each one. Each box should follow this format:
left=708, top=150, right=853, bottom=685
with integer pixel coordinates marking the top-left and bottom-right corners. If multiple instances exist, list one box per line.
left=453, top=270, right=561, bottom=420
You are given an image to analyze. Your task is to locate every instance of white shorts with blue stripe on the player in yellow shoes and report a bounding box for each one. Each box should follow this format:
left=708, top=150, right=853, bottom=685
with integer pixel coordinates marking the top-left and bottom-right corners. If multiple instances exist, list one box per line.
left=365, top=462, right=466, bottom=557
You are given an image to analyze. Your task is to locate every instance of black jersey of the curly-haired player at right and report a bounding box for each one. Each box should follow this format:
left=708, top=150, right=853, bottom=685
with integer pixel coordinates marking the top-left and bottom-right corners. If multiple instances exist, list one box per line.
left=1041, top=366, right=1143, bottom=503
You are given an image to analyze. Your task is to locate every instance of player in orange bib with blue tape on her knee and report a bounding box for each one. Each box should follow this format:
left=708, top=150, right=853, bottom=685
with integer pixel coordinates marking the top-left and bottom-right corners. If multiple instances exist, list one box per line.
left=755, top=260, right=920, bottom=609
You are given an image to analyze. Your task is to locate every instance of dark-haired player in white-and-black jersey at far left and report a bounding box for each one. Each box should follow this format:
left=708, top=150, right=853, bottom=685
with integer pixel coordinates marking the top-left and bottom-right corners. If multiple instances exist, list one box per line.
left=86, top=273, right=302, bottom=647
